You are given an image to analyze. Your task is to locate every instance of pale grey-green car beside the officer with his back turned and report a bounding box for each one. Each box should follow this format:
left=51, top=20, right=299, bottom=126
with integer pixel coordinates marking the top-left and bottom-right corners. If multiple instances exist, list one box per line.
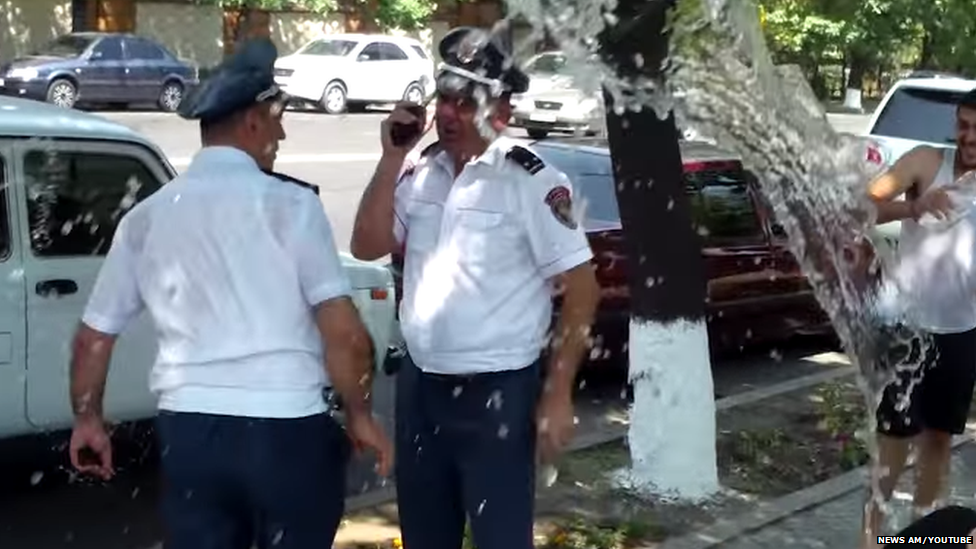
left=0, top=98, right=394, bottom=446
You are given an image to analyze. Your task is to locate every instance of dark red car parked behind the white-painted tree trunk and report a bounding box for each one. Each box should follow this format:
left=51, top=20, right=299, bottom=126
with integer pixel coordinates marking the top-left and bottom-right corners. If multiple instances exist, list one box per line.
left=392, top=138, right=832, bottom=368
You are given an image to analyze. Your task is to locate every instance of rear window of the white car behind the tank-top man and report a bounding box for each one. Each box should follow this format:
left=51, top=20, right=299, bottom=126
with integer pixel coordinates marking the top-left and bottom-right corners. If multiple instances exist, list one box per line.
left=871, top=87, right=963, bottom=144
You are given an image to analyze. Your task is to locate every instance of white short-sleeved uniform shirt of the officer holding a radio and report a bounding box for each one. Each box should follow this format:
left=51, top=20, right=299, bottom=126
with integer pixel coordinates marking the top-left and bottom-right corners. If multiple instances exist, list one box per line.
left=394, top=137, right=593, bottom=374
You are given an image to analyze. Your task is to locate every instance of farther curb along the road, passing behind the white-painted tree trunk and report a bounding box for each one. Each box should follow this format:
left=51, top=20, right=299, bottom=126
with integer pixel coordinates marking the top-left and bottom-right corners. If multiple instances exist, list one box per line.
left=346, top=366, right=855, bottom=512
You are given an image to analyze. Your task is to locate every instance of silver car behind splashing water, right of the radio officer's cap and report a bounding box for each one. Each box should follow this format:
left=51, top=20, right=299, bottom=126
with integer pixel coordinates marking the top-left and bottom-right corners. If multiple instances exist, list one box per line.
left=510, top=51, right=606, bottom=139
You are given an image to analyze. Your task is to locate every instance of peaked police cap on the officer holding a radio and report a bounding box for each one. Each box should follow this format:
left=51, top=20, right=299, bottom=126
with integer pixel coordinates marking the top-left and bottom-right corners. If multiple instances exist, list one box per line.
left=437, top=27, right=529, bottom=97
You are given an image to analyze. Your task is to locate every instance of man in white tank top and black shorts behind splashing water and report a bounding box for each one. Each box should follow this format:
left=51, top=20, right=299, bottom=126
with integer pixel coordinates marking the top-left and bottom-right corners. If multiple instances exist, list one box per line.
left=862, top=90, right=976, bottom=547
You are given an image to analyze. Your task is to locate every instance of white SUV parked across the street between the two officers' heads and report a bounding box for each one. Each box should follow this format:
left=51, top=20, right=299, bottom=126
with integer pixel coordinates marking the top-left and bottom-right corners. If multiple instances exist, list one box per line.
left=275, top=34, right=434, bottom=114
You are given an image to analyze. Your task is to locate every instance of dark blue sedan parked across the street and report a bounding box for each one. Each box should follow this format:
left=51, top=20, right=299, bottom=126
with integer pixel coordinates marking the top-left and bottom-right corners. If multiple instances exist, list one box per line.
left=0, top=32, right=199, bottom=111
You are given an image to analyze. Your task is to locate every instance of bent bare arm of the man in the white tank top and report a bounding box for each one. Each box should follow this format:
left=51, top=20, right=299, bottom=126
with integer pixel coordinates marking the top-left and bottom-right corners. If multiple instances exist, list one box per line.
left=868, top=147, right=941, bottom=224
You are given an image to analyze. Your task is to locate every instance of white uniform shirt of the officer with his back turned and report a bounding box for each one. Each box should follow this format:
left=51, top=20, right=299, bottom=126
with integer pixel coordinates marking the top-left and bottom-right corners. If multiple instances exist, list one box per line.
left=82, top=147, right=350, bottom=418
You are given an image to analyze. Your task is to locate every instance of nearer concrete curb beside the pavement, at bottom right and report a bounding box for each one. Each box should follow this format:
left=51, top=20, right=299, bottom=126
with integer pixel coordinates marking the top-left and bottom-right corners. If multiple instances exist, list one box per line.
left=656, top=434, right=976, bottom=549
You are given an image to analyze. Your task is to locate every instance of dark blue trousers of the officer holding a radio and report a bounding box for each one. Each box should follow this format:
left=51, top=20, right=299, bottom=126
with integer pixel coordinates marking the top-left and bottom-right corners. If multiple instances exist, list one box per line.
left=396, top=357, right=541, bottom=549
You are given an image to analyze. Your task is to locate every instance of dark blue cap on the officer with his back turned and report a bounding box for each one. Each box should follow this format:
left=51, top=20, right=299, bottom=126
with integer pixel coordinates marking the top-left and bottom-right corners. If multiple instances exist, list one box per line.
left=179, top=37, right=285, bottom=122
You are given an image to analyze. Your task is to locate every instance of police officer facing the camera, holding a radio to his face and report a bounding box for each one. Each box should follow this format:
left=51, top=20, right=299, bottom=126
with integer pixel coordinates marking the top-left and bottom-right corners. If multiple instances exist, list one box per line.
left=351, top=28, right=599, bottom=549
